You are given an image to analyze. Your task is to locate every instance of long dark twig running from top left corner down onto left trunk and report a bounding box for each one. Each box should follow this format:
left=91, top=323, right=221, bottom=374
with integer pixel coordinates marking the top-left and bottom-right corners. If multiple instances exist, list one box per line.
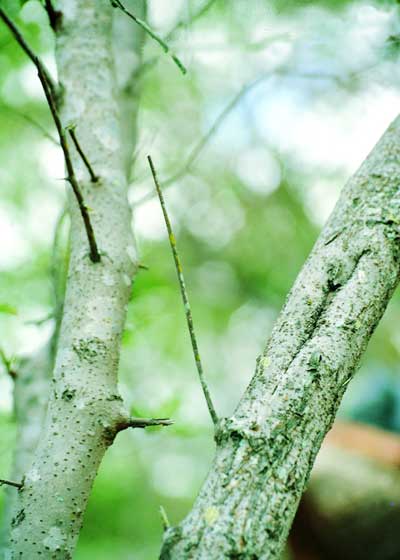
left=0, top=8, right=101, bottom=263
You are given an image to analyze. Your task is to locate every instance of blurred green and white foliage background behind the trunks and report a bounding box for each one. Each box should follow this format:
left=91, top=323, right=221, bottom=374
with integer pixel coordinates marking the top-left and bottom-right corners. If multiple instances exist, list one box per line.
left=0, top=0, right=400, bottom=560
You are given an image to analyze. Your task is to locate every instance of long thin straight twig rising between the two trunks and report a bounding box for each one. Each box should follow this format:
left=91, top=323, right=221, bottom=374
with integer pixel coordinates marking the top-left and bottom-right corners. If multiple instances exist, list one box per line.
left=147, top=156, right=218, bottom=425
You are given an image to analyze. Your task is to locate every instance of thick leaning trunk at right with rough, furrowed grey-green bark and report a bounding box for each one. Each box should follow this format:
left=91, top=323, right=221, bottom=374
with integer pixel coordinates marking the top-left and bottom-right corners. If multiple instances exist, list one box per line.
left=161, top=118, right=400, bottom=560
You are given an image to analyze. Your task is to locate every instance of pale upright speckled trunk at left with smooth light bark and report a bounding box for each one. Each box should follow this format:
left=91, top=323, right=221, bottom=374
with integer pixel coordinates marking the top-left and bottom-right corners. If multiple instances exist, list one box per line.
left=8, top=0, right=136, bottom=560
